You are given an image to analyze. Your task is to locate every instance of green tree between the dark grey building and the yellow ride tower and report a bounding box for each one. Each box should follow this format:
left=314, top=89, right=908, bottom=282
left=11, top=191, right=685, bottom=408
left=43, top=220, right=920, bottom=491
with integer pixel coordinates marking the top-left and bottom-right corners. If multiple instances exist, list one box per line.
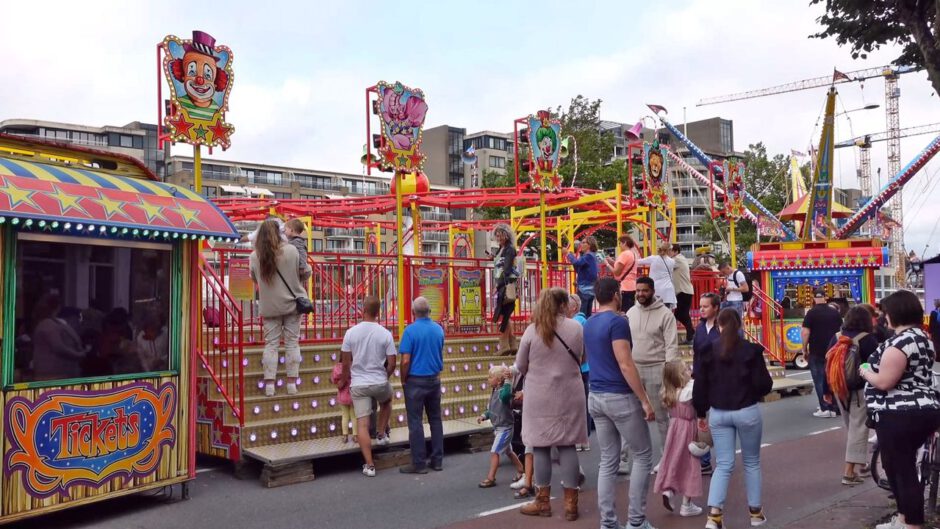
left=698, top=142, right=790, bottom=264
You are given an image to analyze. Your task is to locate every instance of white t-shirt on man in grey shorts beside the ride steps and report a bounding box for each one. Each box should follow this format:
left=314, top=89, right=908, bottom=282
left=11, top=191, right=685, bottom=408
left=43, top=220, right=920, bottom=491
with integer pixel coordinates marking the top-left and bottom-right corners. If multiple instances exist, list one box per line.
left=341, top=321, right=396, bottom=387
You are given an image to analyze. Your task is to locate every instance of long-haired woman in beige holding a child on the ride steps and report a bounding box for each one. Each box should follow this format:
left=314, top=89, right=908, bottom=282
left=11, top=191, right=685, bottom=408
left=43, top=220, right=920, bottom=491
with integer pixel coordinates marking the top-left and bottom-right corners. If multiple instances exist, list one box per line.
left=249, top=220, right=309, bottom=397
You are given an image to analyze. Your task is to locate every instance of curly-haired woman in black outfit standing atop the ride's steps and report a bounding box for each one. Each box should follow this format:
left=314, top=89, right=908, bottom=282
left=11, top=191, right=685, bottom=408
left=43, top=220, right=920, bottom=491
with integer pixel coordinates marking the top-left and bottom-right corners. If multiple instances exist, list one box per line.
left=493, top=224, right=521, bottom=355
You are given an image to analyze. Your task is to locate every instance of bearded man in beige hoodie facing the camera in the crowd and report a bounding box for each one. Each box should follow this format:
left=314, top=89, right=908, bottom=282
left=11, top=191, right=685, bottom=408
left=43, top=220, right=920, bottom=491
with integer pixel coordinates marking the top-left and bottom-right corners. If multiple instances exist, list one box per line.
left=621, top=277, right=681, bottom=473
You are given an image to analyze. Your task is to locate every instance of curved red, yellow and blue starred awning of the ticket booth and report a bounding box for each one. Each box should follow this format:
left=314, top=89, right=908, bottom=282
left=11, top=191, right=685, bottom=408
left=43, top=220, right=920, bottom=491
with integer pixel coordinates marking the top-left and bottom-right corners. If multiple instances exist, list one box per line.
left=0, top=156, right=239, bottom=239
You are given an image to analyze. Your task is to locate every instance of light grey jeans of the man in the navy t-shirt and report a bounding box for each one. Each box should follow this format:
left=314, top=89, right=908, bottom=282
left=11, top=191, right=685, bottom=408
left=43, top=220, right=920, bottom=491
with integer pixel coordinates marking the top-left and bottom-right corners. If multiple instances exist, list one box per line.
left=588, top=392, right=653, bottom=529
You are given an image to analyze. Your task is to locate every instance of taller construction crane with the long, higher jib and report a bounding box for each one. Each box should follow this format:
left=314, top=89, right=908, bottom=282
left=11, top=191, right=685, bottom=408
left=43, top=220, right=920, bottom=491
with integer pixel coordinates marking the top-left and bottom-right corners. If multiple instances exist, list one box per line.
left=696, top=66, right=920, bottom=287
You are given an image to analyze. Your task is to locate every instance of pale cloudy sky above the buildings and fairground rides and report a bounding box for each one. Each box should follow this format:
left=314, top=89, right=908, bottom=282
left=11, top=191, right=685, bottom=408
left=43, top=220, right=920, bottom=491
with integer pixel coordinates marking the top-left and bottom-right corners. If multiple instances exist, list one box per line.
left=0, top=0, right=940, bottom=256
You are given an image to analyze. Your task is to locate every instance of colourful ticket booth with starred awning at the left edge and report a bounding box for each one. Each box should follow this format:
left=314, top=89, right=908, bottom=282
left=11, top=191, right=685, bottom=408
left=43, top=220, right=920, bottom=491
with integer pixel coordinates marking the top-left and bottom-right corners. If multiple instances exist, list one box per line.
left=0, top=135, right=238, bottom=523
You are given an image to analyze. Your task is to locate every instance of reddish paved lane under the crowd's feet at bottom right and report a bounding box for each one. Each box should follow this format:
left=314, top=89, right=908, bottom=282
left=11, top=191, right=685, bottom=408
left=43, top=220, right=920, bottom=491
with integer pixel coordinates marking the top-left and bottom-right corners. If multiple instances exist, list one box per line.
left=447, top=430, right=892, bottom=529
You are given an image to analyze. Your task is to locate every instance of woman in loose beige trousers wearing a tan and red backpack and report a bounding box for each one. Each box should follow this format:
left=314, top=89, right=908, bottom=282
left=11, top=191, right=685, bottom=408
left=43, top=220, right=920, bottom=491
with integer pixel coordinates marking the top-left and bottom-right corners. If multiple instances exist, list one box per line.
left=827, top=305, right=878, bottom=485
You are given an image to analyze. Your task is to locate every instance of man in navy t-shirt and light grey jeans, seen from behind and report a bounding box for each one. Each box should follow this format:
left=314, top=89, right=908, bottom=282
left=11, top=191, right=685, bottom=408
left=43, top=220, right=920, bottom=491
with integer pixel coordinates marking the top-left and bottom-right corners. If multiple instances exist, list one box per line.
left=584, top=277, right=659, bottom=528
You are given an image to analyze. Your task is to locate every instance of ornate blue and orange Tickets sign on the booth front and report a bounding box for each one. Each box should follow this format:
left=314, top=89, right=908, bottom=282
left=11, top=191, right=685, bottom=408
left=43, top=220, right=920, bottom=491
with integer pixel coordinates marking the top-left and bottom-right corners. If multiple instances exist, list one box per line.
left=4, top=382, right=177, bottom=498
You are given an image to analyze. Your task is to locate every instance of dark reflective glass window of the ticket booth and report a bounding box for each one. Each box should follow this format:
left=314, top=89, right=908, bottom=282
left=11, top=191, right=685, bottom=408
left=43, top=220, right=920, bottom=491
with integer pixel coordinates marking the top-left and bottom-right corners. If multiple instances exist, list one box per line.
left=13, top=233, right=173, bottom=382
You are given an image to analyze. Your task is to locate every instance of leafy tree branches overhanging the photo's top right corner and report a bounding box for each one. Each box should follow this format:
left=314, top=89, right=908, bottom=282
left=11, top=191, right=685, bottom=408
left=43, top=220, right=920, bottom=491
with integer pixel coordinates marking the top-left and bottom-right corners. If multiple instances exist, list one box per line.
left=810, top=0, right=940, bottom=94
